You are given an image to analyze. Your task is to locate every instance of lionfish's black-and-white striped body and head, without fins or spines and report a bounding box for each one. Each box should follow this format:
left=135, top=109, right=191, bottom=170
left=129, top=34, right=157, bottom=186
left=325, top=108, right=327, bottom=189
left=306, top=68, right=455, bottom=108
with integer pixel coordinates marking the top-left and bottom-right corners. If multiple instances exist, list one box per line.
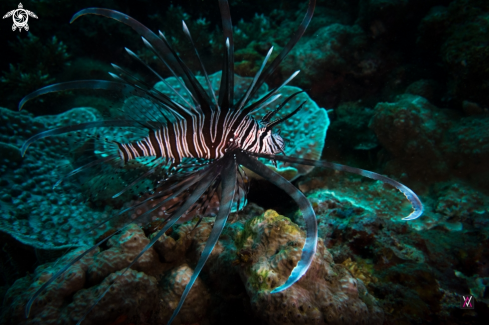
left=115, top=111, right=284, bottom=166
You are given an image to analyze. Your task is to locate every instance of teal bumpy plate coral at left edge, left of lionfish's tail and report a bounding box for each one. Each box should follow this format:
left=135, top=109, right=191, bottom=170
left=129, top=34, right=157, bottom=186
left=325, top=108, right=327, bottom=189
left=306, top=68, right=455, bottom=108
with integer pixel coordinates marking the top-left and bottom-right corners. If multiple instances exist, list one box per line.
left=0, top=107, right=109, bottom=249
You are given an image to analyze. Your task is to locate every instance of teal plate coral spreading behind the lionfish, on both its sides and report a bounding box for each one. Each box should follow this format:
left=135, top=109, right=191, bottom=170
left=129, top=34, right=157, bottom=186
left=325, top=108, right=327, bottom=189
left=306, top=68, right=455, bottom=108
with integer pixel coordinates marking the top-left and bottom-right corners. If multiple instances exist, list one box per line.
left=0, top=66, right=329, bottom=249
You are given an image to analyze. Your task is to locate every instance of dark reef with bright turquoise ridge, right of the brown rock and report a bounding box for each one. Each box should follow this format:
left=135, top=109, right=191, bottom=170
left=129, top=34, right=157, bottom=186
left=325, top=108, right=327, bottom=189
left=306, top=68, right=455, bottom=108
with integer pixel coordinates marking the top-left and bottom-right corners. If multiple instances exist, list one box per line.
left=292, top=169, right=489, bottom=324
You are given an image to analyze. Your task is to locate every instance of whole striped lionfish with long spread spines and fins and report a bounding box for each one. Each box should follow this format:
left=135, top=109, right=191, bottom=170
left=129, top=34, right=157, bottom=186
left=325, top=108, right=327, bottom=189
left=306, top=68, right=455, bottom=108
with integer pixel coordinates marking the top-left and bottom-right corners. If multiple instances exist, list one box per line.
left=19, top=0, right=423, bottom=324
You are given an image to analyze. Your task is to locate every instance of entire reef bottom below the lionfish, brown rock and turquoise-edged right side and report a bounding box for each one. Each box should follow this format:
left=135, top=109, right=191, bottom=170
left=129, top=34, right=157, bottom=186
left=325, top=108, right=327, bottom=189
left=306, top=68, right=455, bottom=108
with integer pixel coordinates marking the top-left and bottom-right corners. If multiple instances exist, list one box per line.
left=1, top=172, right=489, bottom=325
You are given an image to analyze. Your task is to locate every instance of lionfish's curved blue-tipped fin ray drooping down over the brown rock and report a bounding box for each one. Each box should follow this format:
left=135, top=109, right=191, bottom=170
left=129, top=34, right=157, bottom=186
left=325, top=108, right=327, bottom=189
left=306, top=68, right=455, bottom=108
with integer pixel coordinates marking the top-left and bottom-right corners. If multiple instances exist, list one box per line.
left=238, top=153, right=318, bottom=293
